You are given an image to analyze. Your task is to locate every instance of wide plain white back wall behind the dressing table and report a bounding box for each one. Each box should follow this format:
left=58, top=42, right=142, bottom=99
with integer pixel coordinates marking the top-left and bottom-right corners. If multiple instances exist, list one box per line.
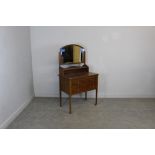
left=31, top=27, right=155, bottom=97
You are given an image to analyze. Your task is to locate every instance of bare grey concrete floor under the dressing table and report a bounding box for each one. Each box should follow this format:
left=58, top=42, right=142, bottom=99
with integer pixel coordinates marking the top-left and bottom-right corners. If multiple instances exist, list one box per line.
left=8, top=98, right=155, bottom=129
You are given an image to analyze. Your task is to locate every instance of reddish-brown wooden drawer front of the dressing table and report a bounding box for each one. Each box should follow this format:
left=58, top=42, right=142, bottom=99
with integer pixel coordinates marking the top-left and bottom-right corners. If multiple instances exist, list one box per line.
left=71, top=76, right=97, bottom=94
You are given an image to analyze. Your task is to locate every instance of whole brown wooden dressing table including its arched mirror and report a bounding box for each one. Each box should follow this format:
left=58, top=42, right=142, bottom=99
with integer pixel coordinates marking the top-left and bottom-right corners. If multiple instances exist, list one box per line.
left=59, top=44, right=98, bottom=114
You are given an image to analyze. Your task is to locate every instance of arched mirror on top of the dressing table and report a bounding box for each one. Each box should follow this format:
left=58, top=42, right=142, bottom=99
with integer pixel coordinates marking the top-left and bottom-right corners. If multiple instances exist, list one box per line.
left=59, top=44, right=85, bottom=65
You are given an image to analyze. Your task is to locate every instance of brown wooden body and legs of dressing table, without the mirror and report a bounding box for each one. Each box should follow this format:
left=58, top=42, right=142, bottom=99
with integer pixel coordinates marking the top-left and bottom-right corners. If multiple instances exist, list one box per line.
left=59, top=44, right=98, bottom=114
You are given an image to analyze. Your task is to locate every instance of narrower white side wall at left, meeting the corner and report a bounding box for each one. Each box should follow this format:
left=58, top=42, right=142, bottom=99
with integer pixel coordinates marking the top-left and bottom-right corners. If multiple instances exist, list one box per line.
left=0, top=27, right=34, bottom=128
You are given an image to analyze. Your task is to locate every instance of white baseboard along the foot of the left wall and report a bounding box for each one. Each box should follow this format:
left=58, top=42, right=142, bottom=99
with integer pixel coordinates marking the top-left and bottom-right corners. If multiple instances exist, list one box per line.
left=0, top=96, right=34, bottom=129
